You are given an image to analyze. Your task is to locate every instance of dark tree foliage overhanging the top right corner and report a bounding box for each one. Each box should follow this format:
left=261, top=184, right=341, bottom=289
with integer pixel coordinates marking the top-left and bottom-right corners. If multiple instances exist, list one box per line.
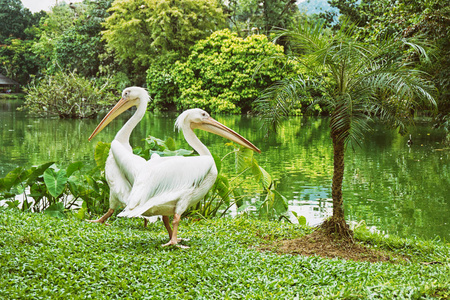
left=330, top=0, right=450, bottom=115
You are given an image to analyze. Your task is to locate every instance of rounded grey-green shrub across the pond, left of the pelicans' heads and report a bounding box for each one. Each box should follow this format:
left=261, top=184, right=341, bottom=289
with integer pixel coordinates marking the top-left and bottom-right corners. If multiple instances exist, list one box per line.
left=20, top=72, right=118, bottom=118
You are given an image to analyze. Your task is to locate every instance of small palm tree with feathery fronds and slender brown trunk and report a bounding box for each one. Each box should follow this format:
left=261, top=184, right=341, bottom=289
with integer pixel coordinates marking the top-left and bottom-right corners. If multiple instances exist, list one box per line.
left=256, top=21, right=435, bottom=238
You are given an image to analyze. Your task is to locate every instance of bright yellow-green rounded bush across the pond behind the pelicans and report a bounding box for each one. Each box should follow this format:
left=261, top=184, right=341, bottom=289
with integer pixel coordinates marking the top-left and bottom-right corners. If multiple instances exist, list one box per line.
left=147, top=30, right=293, bottom=113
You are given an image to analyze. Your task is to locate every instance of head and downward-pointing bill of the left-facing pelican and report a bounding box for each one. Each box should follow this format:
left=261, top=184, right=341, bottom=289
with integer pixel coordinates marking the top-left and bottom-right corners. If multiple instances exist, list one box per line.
left=89, top=86, right=150, bottom=141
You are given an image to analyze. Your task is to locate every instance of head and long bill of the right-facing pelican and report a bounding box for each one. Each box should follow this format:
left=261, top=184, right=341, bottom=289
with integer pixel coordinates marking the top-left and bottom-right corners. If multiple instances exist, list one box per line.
left=175, top=108, right=261, bottom=153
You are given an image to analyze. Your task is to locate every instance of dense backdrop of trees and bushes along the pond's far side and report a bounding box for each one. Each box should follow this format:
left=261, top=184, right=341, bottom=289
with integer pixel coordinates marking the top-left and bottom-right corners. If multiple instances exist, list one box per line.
left=0, top=0, right=450, bottom=119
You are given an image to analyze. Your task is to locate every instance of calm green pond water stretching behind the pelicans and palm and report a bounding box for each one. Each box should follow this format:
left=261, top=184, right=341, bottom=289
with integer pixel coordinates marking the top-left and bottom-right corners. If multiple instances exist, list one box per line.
left=0, top=100, right=450, bottom=241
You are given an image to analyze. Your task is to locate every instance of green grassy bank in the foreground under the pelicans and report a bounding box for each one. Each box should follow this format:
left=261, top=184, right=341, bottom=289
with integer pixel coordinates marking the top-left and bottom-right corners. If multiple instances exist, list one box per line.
left=0, top=208, right=450, bottom=299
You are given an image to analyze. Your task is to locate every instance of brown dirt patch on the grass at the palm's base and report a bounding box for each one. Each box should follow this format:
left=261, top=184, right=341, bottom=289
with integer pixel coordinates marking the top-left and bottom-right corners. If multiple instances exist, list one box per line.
left=261, top=229, right=404, bottom=262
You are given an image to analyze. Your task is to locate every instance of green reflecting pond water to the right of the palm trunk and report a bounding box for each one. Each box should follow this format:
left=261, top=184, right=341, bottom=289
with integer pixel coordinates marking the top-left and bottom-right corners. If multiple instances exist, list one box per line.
left=344, top=126, right=450, bottom=239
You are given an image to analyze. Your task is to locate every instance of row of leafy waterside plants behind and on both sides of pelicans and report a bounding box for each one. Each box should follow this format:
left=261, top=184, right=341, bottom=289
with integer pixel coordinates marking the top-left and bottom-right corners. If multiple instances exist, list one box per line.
left=0, top=136, right=288, bottom=220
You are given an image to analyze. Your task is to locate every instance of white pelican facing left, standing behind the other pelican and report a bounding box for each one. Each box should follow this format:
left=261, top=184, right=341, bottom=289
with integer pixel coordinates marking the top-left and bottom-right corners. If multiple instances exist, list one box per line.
left=88, top=86, right=150, bottom=225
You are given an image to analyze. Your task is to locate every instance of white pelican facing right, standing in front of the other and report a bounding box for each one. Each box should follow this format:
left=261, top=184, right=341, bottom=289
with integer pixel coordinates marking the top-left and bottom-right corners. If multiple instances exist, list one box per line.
left=116, top=108, right=261, bottom=246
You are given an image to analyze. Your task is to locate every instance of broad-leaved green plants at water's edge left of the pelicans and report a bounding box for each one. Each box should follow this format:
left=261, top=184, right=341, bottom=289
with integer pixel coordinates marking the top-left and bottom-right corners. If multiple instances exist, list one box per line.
left=0, top=142, right=109, bottom=219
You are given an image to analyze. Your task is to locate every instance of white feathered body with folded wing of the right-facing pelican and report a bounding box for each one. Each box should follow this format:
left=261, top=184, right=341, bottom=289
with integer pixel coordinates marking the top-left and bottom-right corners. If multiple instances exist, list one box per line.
left=118, top=156, right=217, bottom=217
